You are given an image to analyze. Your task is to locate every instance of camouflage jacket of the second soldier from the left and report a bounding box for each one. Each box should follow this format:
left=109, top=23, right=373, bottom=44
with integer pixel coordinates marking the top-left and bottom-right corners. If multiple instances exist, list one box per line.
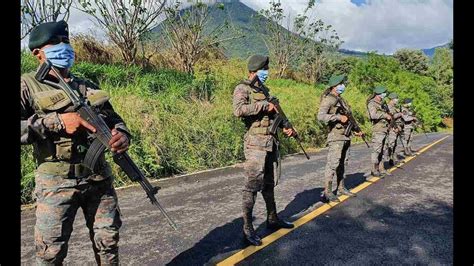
left=233, top=80, right=277, bottom=151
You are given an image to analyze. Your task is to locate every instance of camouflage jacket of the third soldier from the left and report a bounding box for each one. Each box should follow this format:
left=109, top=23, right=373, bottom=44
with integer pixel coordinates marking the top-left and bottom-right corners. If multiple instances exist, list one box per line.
left=318, top=93, right=351, bottom=142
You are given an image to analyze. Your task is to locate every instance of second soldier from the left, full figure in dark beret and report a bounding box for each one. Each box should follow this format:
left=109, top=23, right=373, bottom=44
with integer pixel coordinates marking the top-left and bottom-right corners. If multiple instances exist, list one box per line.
left=233, top=55, right=296, bottom=246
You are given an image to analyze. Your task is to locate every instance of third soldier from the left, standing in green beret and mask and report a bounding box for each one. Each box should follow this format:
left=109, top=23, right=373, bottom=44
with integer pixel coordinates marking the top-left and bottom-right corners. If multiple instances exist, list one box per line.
left=318, top=75, right=362, bottom=202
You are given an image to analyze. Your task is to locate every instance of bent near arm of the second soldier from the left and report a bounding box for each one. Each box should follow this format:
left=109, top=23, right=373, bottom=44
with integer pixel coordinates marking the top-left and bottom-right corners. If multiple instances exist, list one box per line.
left=232, top=85, right=268, bottom=117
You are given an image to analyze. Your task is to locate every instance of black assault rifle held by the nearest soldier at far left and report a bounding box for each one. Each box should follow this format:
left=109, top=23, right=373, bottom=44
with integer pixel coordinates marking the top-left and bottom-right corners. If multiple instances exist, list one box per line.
left=35, top=60, right=177, bottom=230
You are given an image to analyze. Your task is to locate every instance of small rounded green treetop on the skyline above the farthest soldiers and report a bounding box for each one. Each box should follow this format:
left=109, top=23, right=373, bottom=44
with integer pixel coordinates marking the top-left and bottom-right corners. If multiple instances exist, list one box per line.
left=393, top=48, right=429, bottom=75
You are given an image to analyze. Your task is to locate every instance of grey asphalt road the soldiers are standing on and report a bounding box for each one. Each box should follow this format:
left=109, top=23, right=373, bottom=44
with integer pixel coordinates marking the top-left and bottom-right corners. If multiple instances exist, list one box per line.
left=21, top=134, right=452, bottom=265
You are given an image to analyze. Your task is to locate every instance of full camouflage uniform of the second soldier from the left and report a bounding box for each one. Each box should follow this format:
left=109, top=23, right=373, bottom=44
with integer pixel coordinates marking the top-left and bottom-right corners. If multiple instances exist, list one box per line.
left=233, top=80, right=286, bottom=241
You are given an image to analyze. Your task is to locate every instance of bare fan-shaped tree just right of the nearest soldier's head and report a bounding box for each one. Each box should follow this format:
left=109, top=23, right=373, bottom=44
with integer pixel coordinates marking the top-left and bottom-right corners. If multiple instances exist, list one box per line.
left=78, top=0, right=166, bottom=64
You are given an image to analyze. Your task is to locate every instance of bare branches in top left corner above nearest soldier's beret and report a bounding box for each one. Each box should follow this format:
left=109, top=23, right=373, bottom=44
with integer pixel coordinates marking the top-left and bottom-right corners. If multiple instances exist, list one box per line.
left=21, top=0, right=72, bottom=40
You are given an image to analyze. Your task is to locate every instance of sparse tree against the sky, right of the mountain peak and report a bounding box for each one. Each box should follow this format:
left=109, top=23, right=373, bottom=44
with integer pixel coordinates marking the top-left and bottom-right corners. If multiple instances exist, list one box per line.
left=255, top=0, right=341, bottom=80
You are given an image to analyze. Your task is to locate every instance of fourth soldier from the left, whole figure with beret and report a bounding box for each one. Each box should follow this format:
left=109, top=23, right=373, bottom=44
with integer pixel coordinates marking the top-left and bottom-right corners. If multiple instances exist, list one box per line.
left=367, top=86, right=391, bottom=178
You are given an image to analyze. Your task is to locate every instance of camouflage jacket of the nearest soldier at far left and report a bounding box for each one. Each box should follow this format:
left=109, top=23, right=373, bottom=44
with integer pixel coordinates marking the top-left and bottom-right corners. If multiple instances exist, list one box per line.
left=20, top=69, right=131, bottom=176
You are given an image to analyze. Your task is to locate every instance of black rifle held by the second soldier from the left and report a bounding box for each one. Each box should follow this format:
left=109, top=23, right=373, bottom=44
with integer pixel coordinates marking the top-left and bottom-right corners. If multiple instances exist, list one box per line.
left=250, top=75, right=310, bottom=160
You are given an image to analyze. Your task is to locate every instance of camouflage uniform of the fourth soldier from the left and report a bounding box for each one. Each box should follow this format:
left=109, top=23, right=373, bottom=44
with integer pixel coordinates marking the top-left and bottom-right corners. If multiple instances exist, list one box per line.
left=367, top=97, right=389, bottom=175
